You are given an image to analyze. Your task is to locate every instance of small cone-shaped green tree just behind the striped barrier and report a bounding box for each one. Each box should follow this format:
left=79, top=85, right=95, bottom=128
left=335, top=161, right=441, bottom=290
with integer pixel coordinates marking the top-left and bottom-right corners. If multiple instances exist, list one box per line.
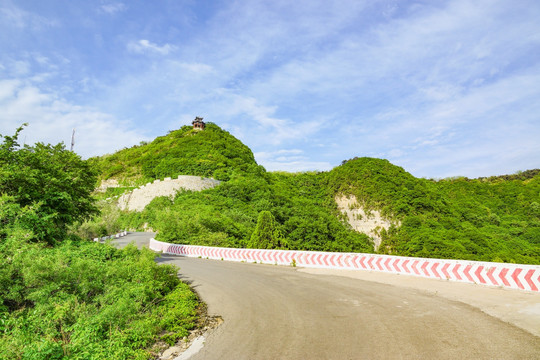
left=248, top=210, right=288, bottom=249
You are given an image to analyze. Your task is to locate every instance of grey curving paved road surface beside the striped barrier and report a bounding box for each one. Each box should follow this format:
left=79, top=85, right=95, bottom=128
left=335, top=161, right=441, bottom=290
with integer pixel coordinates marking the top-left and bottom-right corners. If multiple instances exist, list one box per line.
left=115, top=234, right=540, bottom=360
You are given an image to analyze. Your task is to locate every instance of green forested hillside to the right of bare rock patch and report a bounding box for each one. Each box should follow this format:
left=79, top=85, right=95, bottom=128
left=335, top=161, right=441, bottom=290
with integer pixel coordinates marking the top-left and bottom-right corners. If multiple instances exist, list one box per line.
left=329, top=158, right=540, bottom=264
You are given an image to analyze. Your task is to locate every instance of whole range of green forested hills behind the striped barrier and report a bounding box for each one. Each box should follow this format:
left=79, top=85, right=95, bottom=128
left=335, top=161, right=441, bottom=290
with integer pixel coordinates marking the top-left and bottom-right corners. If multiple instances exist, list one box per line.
left=93, top=124, right=540, bottom=264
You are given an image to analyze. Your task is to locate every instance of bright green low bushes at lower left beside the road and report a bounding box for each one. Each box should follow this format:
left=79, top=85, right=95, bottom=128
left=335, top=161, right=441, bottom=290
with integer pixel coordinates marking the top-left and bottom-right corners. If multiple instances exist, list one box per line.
left=0, top=236, right=198, bottom=360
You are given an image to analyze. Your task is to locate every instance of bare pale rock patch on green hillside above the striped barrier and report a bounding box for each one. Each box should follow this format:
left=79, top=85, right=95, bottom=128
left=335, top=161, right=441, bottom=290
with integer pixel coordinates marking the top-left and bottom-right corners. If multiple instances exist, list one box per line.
left=335, top=195, right=401, bottom=250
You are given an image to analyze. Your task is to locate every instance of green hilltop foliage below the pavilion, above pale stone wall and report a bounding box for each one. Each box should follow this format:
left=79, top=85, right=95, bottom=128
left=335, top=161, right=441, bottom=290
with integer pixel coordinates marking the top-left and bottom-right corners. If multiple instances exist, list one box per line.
left=91, top=123, right=259, bottom=184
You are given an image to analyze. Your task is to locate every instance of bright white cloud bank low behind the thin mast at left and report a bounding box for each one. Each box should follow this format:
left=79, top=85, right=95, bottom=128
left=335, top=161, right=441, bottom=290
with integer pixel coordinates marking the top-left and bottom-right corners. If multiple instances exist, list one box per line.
left=0, top=80, right=148, bottom=157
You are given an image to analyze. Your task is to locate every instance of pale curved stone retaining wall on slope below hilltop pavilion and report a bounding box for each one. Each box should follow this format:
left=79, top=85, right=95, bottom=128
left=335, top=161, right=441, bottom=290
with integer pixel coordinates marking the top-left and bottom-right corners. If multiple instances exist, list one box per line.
left=118, top=175, right=221, bottom=211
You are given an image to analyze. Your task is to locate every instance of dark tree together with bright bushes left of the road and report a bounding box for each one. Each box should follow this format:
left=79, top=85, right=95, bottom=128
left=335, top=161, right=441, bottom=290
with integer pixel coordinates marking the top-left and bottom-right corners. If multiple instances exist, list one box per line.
left=0, top=128, right=199, bottom=359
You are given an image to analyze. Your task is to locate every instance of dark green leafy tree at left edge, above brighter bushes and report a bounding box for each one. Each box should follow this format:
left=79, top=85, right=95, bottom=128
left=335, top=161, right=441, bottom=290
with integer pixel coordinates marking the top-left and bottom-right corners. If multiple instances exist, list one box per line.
left=0, top=124, right=97, bottom=243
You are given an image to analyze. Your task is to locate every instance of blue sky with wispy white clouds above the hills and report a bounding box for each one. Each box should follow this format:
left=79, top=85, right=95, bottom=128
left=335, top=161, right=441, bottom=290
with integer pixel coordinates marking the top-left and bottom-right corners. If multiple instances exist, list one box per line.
left=0, top=0, right=540, bottom=178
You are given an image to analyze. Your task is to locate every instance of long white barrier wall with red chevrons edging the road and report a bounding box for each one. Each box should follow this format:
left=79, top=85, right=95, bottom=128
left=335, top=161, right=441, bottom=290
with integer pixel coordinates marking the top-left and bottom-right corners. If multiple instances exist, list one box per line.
left=149, top=239, right=540, bottom=291
